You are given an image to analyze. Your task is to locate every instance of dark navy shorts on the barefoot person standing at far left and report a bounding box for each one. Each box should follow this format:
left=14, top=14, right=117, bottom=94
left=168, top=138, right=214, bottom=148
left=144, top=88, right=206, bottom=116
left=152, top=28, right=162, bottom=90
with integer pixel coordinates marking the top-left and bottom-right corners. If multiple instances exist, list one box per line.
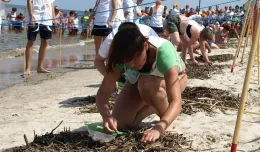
left=27, top=24, right=52, bottom=41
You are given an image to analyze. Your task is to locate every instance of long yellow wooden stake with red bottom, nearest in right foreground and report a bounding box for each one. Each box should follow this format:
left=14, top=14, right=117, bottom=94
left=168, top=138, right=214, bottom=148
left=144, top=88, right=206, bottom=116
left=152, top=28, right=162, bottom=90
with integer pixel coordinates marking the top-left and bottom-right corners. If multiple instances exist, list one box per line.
left=231, top=0, right=260, bottom=152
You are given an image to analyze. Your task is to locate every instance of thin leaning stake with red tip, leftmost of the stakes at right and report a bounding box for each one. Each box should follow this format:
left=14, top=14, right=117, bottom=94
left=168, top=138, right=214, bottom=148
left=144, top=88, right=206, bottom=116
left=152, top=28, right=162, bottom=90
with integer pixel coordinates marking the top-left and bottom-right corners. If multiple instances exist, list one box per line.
left=231, top=1, right=252, bottom=72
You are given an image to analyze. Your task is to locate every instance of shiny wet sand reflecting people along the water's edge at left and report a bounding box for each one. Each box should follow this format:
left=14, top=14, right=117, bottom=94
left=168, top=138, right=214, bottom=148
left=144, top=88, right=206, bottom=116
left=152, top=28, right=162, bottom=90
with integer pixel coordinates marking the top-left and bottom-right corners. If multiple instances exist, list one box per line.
left=0, top=44, right=95, bottom=89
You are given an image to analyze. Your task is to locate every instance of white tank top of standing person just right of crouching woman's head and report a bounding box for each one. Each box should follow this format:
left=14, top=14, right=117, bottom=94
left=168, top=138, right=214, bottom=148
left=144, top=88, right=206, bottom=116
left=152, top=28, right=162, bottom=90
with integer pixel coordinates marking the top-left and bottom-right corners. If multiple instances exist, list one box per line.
left=150, top=5, right=164, bottom=27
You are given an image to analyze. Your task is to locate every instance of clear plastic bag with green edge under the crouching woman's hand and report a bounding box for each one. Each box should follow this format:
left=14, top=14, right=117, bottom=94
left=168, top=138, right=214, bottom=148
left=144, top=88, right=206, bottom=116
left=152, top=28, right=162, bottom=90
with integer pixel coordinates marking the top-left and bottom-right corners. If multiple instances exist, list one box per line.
left=87, top=124, right=128, bottom=142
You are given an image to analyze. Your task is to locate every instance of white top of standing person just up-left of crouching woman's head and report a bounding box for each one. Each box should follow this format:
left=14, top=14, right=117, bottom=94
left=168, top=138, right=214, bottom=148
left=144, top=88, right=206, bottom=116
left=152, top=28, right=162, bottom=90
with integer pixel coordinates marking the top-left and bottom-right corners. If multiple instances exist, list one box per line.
left=94, top=0, right=112, bottom=26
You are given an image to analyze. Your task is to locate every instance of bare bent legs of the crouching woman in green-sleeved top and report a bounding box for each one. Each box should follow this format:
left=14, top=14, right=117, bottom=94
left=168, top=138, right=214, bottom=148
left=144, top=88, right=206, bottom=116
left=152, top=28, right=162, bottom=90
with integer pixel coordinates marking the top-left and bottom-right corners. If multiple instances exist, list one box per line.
left=112, top=76, right=187, bottom=128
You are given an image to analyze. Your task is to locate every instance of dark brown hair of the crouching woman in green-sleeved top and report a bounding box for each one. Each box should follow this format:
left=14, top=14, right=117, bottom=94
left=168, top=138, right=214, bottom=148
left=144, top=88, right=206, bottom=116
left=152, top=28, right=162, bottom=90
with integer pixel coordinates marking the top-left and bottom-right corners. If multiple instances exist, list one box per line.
left=107, top=27, right=147, bottom=72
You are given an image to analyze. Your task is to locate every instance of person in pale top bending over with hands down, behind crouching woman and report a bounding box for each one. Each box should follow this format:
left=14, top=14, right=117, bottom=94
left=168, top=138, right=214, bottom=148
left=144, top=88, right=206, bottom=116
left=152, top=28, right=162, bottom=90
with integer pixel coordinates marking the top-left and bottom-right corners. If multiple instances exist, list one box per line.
left=167, top=15, right=214, bottom=65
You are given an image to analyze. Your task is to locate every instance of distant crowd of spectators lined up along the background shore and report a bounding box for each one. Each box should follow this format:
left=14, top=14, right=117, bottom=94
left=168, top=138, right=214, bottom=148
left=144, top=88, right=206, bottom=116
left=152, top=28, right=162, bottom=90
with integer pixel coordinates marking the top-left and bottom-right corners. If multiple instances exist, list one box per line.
left=6, top=0, right=245, bottom=38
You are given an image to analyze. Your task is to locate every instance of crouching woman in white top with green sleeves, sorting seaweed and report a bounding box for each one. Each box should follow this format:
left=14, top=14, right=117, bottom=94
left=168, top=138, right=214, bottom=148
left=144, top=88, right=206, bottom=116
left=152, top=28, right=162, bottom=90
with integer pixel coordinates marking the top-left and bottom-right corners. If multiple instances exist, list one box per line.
left=96, top=28, right=187, bottom=144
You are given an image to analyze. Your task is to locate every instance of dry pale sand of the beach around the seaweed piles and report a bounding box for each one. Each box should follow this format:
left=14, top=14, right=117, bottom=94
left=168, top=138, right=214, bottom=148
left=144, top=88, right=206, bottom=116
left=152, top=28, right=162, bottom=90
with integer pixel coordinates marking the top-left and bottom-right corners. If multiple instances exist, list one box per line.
left=0, top=49, right=260, bottom=152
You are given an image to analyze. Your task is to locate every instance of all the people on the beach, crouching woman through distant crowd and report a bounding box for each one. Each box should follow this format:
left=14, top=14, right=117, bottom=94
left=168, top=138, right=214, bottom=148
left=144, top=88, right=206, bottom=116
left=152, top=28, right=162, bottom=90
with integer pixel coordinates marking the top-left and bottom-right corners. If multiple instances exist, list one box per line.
left=2, top=0, right=244, bottom=144
